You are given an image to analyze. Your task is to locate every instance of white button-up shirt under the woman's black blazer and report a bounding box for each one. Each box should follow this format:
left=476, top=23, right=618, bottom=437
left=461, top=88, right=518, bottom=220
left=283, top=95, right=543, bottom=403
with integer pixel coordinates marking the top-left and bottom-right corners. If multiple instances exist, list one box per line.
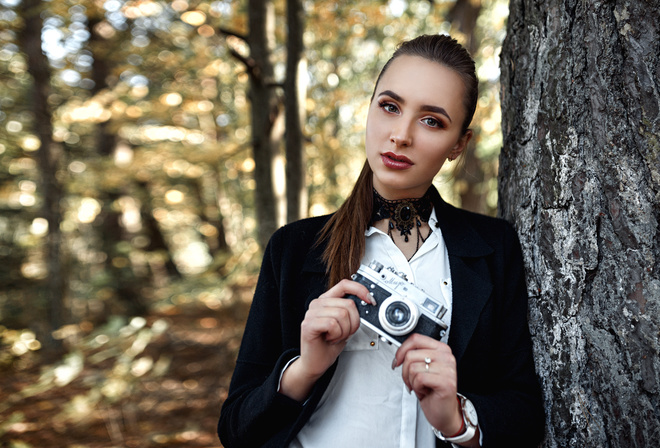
left=290, top=210, right=452, bottom=448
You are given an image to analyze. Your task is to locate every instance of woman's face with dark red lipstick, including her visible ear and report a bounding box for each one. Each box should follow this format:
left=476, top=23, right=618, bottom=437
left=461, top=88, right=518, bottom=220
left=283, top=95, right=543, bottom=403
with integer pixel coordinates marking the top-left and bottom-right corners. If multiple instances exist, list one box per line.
left=366, top=55, right=472, bottom=199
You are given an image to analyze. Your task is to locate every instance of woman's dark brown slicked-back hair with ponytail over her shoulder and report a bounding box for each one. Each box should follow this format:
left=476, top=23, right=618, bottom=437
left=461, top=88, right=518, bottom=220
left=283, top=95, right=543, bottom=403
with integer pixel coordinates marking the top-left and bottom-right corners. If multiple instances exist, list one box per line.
left=319, top=35, right=479, bottom=286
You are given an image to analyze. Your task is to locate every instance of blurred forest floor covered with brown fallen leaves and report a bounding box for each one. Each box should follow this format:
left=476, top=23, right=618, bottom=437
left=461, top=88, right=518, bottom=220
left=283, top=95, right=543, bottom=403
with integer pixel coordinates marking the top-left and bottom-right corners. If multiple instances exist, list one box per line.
left=0, top=285, right=252, bottom=448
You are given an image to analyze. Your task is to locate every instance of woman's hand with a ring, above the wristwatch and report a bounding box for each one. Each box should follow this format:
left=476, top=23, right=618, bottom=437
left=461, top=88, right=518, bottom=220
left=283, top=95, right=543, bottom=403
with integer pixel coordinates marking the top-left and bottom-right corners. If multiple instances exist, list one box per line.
left=392, top=333, right=463, bottom=435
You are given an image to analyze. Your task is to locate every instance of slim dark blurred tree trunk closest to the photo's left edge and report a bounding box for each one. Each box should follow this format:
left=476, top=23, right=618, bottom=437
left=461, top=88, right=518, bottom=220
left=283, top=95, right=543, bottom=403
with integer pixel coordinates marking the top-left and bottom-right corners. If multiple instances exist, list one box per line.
left=19, top=0, right=66, bottom=354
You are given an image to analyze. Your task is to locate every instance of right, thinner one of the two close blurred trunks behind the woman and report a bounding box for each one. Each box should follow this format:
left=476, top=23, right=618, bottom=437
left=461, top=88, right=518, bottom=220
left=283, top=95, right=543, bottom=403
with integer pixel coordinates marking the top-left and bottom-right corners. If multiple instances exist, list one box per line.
left=284, top=0, right=308, bottom=222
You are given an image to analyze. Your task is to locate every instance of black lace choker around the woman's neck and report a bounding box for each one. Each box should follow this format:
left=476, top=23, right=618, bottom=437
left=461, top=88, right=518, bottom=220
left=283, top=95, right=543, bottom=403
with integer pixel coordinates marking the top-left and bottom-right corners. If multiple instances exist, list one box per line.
left=371, top=189, right=433, bottom=245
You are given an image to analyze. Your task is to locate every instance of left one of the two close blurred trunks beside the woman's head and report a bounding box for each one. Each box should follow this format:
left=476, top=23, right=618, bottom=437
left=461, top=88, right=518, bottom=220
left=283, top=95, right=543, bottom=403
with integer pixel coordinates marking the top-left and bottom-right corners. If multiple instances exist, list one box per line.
left=247, top=0, right=286, bottom=247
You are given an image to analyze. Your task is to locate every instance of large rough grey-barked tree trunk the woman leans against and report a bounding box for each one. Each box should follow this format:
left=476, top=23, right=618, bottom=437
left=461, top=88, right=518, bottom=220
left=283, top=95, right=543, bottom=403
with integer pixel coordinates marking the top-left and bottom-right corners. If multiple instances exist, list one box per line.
left=499, top=0, right=660, bottom=447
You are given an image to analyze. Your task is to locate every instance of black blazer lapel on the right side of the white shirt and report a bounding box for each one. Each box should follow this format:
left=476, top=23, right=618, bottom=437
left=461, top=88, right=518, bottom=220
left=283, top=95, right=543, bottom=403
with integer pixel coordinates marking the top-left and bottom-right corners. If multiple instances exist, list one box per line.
left=433, top=191, right=493, bottom=363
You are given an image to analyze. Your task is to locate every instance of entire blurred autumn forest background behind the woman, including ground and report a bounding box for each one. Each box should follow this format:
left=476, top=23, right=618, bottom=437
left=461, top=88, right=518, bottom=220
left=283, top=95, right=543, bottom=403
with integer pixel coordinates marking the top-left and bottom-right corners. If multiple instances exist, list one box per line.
left=0, top=0, right=508, bottom=448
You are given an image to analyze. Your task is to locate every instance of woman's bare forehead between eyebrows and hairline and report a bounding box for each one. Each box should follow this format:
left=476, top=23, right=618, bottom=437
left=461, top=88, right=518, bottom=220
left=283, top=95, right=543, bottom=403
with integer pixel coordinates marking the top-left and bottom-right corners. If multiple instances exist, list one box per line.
left=376, top=55, right=465, bottom=108
